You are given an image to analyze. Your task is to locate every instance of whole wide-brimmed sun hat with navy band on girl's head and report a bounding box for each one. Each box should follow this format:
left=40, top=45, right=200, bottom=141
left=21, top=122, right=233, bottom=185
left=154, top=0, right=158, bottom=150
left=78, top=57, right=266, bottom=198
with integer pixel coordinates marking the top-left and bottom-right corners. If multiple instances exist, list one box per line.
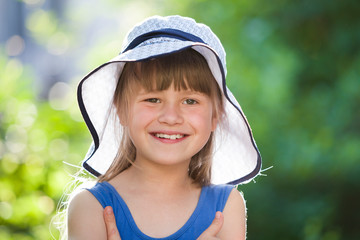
left=77, top=16, right=261, bottom=185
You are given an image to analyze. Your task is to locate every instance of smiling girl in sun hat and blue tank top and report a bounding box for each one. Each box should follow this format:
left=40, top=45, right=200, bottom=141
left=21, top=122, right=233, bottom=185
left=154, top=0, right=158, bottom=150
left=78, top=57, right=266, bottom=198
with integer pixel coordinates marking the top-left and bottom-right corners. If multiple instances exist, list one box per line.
left=68, top=16, right=261, bottom=240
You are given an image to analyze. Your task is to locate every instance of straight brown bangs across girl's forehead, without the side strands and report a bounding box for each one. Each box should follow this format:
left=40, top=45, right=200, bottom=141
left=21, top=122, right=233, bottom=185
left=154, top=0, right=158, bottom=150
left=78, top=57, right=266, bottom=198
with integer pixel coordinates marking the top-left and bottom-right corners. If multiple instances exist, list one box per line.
left=124, top=48, right=218, bottom=97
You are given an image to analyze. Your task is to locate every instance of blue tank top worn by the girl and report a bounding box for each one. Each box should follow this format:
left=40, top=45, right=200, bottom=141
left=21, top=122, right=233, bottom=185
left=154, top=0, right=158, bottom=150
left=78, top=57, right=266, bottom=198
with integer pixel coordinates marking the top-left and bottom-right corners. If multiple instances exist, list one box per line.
left=88, top=182, right=234, bottom=240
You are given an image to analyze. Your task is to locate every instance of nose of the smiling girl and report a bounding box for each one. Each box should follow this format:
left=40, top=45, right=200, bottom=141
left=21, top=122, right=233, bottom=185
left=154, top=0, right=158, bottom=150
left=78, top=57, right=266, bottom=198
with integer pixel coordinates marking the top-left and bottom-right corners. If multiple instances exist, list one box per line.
left=158, top=103, right=184, bottom=125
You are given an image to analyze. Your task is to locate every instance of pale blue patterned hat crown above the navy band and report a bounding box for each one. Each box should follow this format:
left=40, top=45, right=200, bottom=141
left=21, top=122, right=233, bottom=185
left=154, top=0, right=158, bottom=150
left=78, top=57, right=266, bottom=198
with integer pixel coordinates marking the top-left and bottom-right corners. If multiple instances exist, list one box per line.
left=122, top=15, right=226, bottom=74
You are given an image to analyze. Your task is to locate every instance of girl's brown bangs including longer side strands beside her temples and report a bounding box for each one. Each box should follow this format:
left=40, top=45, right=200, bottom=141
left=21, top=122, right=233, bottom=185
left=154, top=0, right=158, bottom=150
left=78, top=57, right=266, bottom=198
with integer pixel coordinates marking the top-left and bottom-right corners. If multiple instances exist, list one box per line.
left=113, top=48, right=224, bottom=119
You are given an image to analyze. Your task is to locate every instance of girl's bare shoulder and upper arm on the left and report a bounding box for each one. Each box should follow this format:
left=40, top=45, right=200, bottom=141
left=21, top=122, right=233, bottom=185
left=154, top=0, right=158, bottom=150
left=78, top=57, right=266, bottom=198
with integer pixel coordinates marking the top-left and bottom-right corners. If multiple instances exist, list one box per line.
left=67, top=190, right=106, bottom=239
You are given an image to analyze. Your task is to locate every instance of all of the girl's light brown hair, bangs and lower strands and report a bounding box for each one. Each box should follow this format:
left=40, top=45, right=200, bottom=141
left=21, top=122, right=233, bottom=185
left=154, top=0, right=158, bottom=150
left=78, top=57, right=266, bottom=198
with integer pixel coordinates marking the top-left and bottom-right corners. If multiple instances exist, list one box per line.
left=98, top=48, right=224, bottom=186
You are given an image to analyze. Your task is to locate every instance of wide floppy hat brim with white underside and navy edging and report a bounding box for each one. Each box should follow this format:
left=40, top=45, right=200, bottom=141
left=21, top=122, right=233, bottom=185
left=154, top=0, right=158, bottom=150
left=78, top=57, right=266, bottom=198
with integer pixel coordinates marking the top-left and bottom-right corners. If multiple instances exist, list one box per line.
left=78, top=41, right=261, bottom=184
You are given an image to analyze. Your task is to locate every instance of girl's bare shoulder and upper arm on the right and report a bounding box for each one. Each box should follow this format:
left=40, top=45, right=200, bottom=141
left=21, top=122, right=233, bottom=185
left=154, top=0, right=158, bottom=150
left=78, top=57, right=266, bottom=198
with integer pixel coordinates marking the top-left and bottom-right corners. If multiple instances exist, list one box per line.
left=218, top=188, right=246, bottom=239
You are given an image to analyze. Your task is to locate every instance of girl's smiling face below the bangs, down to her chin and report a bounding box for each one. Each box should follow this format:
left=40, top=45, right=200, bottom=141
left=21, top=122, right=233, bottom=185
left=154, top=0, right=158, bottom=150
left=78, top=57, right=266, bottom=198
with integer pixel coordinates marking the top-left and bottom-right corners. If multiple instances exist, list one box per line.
left=125, top=87, right=216, bottom=168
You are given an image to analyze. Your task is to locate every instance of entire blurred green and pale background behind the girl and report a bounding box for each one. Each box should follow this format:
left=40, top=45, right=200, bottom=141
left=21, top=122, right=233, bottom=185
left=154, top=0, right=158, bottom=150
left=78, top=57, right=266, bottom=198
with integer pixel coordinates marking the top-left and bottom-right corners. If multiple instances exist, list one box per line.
left=0, top=0, right=360, bottom=240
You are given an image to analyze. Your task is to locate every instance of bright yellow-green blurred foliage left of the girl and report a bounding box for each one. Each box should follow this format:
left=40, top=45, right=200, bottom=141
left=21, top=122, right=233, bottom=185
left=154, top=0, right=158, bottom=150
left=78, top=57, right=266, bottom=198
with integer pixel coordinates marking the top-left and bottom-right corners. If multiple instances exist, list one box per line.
left=0, top=51, right=89, bottom=239
